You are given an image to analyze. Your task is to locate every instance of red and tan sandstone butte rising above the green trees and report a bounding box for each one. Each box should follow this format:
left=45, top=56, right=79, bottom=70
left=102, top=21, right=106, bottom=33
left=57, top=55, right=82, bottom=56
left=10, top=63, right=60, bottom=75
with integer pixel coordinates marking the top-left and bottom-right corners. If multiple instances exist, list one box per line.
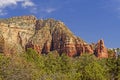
left=0, top=15, right=108, bottom=58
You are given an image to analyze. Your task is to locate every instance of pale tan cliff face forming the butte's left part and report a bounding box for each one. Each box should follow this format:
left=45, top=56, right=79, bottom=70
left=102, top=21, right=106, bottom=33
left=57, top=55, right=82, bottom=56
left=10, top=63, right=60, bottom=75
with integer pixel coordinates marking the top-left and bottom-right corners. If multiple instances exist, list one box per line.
left=0, top=16, right=36, bottom=54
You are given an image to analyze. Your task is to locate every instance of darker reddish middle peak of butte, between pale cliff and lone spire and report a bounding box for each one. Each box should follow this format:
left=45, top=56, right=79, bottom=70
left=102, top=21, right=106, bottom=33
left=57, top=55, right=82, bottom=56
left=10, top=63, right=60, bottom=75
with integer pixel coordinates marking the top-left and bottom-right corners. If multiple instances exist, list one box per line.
left=26, top=19, right=93, bottom=57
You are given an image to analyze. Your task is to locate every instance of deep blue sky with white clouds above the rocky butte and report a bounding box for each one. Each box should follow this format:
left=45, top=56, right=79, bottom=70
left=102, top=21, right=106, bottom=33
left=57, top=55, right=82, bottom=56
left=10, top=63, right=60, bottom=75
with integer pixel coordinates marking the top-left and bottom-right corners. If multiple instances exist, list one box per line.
left=0, top=0, right=120, bottom=48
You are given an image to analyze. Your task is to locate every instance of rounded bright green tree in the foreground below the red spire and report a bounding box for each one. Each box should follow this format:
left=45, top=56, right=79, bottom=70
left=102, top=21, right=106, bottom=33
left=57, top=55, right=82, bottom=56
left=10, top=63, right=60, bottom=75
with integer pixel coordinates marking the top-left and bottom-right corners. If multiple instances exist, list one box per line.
left=76, top=54, right=107, bottom=80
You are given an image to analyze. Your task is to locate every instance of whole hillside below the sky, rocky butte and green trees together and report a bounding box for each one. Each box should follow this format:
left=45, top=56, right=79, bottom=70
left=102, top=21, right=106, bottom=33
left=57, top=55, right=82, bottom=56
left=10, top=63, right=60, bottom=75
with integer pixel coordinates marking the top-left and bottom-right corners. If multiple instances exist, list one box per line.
left=0, top=16, right=120, bottom=80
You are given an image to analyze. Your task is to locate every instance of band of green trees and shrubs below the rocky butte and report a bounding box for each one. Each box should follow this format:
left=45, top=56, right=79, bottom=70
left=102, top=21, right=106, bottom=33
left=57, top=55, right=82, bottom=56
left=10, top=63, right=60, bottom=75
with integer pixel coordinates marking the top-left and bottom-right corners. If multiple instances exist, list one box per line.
left=0, top=49, right=120, bottom=80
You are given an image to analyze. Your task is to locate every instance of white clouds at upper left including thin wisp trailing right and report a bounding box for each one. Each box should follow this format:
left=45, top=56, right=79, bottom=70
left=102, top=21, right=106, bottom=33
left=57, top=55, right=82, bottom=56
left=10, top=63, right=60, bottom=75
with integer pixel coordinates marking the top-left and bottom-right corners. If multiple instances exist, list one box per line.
left=0, top=0, right=56, bottom=16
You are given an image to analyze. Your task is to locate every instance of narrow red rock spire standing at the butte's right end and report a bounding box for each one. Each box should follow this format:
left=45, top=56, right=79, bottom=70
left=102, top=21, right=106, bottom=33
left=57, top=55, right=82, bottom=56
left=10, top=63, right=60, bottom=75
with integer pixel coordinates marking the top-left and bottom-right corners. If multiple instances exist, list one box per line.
left=95, top=40, right=108, bottom=58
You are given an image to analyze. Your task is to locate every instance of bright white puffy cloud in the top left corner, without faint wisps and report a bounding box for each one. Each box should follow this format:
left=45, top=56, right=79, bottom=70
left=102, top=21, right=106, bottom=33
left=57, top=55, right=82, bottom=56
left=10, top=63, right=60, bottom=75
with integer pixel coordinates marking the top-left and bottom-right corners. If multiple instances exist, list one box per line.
left=0, top=0, right=35, bottom=15
